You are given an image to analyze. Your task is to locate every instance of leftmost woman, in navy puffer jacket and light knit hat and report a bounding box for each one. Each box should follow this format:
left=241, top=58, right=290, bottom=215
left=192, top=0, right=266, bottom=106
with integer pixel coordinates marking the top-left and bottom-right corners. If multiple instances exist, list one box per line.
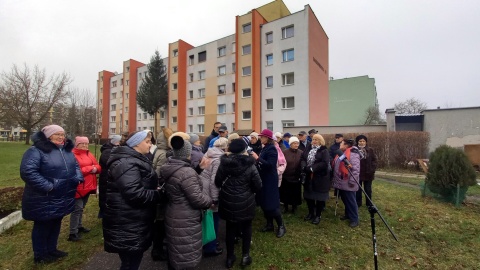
left=20, top=125, right=83, bottom=263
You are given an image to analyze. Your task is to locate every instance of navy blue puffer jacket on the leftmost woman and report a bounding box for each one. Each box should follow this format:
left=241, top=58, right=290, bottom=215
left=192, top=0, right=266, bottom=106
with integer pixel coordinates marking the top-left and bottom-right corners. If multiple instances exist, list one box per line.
left=20, top=131, right=83, bottom=221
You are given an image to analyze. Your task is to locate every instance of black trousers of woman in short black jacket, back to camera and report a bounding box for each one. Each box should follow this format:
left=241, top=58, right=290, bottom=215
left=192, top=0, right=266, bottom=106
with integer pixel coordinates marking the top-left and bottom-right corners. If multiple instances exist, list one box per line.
left=226, top=220, right=252, bottom=258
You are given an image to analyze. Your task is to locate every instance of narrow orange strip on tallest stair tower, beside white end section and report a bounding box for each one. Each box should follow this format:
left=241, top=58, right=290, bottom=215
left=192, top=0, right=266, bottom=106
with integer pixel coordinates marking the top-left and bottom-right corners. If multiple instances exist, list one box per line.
left=251, top=9, right=267, bottom=131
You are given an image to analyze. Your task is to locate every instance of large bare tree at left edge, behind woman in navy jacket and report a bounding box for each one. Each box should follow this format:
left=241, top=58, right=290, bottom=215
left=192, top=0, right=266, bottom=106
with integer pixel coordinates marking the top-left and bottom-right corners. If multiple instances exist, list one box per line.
left=0, top=64, right=71, bottom=144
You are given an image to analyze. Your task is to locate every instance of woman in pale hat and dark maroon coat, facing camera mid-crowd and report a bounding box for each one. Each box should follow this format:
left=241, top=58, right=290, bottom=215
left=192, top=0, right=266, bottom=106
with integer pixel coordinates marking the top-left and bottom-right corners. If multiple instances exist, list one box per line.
left=280, top=137, right=303, bottom=214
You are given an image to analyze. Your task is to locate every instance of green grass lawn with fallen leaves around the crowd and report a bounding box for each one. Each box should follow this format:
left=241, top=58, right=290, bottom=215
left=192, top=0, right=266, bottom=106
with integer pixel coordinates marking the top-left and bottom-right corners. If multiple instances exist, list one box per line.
left=0, top=144, right=480, bottom=270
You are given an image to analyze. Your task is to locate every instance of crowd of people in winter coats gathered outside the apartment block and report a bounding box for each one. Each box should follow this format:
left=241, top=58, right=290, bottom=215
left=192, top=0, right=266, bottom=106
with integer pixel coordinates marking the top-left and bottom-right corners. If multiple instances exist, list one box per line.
left=20, top=122, right=376, bottom=269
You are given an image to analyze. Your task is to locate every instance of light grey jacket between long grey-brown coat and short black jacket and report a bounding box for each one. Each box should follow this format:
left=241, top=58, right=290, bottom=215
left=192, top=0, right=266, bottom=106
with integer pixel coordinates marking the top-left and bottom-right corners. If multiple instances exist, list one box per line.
left=200, top=147, right=225, bottom=204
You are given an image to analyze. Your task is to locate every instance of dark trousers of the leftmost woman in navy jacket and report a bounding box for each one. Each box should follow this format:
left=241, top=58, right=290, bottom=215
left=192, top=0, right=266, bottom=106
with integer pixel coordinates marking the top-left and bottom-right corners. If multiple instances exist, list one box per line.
left=32, top=218, right=62, bottom=258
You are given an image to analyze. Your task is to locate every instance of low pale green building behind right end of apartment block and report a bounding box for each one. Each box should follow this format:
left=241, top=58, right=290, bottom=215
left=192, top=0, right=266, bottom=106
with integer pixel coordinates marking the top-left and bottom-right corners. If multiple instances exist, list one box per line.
left=329, top=76, right=378, bottom=126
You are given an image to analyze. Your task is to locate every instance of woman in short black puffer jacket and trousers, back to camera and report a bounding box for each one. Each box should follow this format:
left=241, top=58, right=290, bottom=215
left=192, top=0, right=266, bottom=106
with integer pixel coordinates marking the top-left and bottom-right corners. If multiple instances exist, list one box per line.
left=215, top=139, right=262, bottom=268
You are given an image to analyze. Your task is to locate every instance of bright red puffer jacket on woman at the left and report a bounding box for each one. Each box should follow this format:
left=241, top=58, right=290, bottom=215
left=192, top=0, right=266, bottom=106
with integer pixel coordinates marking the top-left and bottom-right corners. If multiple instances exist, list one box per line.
left=72, top=148, right=102, bottom=199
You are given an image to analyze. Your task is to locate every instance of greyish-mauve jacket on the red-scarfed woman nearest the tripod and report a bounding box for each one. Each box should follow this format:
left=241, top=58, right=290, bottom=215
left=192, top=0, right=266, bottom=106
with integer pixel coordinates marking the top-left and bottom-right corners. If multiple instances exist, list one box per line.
left=333, top=146, right=360, bottom=191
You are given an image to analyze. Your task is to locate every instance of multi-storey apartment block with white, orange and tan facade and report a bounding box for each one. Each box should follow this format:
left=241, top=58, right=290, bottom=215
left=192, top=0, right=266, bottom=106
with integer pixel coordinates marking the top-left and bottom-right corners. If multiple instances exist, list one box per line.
left=97, top=0, right=329, bottom=138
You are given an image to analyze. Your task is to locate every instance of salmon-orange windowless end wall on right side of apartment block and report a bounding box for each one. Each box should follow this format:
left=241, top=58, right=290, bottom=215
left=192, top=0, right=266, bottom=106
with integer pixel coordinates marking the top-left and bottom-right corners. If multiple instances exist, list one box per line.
left=306, top=5, right=329, bottom=126
